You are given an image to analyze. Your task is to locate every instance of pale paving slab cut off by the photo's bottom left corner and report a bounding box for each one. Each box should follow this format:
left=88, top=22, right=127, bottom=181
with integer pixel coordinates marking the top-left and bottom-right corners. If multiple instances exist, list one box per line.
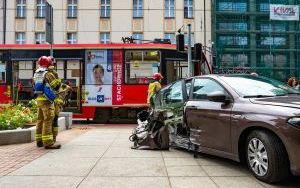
left=0, top=176, right=83, bottom=188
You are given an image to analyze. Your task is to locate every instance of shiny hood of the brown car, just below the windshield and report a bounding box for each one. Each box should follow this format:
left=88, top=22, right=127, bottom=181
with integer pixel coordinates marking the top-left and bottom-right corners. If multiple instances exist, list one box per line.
left=250, top=95, right=300, bottom=108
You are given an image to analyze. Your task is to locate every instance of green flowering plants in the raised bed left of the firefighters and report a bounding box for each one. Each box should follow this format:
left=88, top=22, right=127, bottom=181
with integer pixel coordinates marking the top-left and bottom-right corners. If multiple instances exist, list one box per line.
left=0, top=100, right=37, bottom=130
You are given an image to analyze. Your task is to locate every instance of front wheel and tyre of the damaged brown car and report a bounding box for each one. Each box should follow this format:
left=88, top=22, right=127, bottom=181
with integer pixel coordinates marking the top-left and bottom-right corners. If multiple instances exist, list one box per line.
left=245, top=130, right=289, bottom=183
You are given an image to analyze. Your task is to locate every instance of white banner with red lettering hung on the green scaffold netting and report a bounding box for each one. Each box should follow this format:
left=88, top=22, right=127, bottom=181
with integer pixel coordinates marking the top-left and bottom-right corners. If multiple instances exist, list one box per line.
left=270, top=4, right=299, bottom=21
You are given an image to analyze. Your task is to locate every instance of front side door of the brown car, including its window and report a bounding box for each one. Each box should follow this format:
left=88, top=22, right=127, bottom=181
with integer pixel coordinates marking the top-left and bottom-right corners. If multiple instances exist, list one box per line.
left=185, top=78, right=232, bottom=152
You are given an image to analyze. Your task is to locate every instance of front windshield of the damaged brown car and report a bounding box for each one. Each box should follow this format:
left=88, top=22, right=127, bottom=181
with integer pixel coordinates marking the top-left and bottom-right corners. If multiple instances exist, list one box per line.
left=221, top=75, right=300, bottom=98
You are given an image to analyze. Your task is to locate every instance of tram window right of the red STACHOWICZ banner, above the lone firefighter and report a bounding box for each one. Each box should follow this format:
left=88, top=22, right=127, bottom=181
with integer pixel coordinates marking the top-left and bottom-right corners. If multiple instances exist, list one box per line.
left=125, top=50, right=160, bottom=84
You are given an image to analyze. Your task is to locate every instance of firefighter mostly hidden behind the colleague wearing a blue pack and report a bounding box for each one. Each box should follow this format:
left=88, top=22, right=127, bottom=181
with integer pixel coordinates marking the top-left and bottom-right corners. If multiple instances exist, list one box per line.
left=48, top=56, right=64, bottom=142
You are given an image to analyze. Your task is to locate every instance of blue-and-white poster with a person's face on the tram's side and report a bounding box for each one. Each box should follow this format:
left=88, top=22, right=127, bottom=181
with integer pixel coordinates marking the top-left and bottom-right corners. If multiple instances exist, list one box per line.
left=84, top=50, right=112, bottom=106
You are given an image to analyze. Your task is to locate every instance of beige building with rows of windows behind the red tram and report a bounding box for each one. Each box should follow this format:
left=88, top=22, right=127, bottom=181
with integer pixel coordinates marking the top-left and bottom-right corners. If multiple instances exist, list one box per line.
left=0, top=0, right=211, bottom=45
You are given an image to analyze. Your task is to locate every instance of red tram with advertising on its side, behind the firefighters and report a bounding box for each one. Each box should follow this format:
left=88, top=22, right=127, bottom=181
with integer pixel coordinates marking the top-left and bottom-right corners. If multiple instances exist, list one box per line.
left=0, top=43, right=212, bottom=123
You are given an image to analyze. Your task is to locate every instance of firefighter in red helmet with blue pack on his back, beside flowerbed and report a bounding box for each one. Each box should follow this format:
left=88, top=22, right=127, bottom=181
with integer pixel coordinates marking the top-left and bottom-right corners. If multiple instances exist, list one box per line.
left=33, top=56, right=61, bottom=149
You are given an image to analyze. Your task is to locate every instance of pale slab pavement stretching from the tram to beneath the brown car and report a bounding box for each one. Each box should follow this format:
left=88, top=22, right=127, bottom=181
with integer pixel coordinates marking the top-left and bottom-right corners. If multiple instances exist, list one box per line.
left=0, top=125, right=300, bottom=188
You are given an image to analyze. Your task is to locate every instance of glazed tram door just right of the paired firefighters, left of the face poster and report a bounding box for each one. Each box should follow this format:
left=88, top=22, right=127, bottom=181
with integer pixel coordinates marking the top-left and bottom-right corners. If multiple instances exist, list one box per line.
left=56, top=59, right=82, bottom=113
